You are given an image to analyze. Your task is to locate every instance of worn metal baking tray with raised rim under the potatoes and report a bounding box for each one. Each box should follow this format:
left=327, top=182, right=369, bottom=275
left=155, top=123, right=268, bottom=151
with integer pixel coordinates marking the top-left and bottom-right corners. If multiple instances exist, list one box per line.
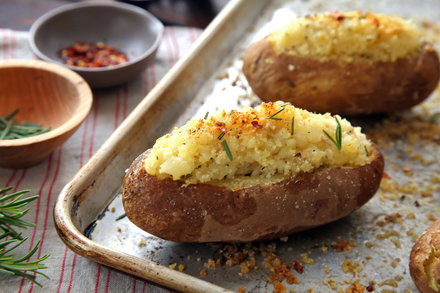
left=54, top=0, right=440, bottom=292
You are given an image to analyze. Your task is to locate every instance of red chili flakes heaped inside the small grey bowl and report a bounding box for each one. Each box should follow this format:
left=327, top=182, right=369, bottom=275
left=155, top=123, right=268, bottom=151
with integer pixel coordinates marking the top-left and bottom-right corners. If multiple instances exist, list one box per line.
left=58, top=42, right=128, bottom=67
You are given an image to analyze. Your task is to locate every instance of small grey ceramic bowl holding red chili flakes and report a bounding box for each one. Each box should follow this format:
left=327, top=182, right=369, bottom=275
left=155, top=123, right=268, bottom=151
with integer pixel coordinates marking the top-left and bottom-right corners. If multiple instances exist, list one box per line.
left=29, top=2, right=164, bottom=88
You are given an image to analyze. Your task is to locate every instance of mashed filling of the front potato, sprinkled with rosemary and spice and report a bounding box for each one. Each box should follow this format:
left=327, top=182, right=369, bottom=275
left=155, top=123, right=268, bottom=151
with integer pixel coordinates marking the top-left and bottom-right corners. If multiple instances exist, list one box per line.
left=143, top=102, right=372, bottom=189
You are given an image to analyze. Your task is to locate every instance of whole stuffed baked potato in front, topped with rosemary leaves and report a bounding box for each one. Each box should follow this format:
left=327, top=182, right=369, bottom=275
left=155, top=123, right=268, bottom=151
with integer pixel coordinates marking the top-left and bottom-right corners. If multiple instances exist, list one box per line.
left=122, top=102, right=384, bottom=242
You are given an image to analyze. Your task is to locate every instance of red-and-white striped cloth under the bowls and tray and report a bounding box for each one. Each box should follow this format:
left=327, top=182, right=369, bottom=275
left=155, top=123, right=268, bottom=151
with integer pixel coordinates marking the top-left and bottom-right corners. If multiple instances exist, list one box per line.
left=0, top=27, right=201, bottom=292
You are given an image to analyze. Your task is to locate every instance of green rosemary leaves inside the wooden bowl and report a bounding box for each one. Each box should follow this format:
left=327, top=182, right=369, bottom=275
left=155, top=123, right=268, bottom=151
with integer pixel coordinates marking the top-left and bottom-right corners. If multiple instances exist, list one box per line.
left=0, top=109, right=50, bottom=139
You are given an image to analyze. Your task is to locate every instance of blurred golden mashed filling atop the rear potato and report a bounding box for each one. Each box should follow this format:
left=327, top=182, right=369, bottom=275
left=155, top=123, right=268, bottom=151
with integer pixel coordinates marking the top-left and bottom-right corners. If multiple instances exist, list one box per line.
left=268, top=11, right=423, bottom=62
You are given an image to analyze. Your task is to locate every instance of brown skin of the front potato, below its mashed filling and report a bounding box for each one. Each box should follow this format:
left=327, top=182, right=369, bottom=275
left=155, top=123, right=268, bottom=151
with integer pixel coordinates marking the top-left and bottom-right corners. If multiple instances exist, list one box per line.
left=122, top=145, right=384, bottom=242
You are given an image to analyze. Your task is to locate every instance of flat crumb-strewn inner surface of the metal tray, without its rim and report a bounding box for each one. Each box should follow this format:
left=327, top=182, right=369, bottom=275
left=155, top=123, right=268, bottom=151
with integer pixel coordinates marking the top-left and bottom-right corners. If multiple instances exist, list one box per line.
left=86, top=0, right=440, bottom=292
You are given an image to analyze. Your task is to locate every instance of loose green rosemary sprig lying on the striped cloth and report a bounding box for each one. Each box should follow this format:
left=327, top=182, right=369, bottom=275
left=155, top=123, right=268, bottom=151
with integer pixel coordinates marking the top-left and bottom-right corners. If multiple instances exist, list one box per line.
left=0, top=187, right=50, bottom=286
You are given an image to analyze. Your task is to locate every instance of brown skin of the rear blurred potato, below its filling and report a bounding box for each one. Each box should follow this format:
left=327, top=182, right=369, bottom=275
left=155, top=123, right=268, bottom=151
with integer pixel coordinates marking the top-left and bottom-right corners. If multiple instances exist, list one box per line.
left=243, top=38, right=440, bottom=115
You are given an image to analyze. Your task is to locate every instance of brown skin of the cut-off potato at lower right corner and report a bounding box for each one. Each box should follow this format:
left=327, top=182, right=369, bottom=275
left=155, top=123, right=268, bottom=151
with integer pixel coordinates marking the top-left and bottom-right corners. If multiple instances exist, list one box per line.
left=409, top=219, right=440, bottom=293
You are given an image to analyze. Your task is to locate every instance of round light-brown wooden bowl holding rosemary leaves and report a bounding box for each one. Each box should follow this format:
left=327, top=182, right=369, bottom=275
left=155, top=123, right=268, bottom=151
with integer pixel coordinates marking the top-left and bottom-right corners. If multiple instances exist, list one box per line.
left=0, top=60, right=93, bottom=168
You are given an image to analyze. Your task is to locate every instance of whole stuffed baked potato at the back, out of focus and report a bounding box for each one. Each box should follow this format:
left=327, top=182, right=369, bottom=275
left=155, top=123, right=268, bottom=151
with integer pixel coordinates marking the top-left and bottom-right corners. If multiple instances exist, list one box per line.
left=243, top=11, right=440, bottom=115
